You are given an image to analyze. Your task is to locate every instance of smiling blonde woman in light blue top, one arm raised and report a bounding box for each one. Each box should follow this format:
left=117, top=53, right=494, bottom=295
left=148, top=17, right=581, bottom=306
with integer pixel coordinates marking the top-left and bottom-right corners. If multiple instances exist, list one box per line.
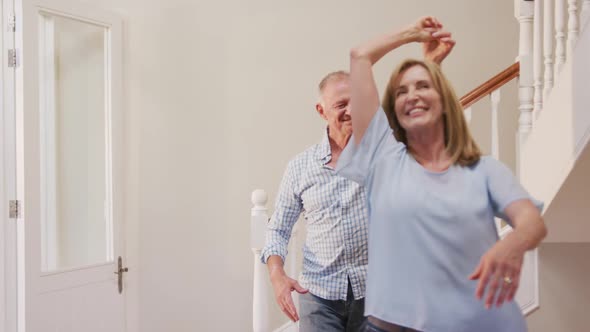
left=337, top=17, right=546, bottom=332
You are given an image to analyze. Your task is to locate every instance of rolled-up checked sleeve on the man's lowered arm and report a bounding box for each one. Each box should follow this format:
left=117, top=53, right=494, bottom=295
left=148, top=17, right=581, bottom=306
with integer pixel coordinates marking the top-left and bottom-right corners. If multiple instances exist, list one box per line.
left=261, top=161, right=303, bottom=264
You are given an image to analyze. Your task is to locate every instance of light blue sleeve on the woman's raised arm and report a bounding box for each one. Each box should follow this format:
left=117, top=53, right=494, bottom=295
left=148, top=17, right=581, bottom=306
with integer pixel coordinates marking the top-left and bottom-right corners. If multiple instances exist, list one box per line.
left=336, top=107, right=402, bottom=186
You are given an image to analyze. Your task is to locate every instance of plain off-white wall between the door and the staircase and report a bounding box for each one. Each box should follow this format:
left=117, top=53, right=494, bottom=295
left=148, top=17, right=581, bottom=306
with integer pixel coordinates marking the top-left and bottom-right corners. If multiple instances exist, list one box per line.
left=74, top=0, right=518, bottom=332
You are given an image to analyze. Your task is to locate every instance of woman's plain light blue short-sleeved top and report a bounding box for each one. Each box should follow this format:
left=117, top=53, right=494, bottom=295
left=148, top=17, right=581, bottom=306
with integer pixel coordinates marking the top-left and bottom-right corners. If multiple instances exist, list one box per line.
left=337, top=110, right=530, bottom=332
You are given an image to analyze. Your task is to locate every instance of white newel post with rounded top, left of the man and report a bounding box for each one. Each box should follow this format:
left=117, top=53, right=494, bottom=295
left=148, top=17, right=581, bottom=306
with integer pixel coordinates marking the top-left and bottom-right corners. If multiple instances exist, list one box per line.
left=250, top=189, right=270, bottom=332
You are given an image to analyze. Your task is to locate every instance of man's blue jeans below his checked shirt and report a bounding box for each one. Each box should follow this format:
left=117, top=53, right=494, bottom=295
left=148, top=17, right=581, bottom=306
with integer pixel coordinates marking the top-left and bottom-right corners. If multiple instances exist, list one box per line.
left=299, top=282, right=365, bottom=332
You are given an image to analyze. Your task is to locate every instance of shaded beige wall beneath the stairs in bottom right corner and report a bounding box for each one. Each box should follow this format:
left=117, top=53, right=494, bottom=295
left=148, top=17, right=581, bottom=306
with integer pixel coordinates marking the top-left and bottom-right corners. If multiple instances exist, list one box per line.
left=527, top=243, right=590, bottom=332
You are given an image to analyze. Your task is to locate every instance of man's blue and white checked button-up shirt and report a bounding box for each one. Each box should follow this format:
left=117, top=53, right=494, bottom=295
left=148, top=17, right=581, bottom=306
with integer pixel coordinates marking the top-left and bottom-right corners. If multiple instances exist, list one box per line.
left=262, top=133, right=368, bottom=300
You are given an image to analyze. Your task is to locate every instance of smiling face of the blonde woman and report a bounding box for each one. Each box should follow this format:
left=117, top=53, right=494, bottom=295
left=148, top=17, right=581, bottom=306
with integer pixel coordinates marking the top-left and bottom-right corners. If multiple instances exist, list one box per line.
left=393, top=65, right=443, bottom=135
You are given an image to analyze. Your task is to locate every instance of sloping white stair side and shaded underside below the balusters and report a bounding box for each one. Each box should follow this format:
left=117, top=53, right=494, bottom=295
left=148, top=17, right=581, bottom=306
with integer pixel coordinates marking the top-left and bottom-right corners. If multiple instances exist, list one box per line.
left=521, top=13, right=590, bottom=243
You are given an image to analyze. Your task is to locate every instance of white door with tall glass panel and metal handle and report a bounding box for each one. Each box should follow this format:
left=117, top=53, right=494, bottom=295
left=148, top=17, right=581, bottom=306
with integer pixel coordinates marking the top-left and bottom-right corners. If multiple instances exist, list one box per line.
left=16, top=0, right=125, bottom=332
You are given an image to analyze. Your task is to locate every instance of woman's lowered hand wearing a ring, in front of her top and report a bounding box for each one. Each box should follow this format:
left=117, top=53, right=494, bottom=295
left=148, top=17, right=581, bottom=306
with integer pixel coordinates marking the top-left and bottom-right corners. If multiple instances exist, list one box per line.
left=469, top=239, right=526, bottom=309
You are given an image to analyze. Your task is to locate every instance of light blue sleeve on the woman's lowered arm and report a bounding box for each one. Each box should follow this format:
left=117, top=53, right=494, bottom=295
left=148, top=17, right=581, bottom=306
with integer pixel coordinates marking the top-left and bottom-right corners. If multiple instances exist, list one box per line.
left=485, top=157, right=543, bottom=226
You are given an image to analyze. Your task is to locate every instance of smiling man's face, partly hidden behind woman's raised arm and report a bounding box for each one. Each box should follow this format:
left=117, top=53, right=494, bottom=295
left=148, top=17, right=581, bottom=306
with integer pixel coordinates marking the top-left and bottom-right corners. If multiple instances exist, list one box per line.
left=316, top=77, right=352, bottom=137
